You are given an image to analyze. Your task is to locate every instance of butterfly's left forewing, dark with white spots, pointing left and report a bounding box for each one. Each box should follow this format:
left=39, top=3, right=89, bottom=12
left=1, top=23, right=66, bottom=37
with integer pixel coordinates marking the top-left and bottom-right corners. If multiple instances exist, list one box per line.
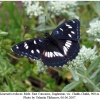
left=12, top=38, right=44, bottom=60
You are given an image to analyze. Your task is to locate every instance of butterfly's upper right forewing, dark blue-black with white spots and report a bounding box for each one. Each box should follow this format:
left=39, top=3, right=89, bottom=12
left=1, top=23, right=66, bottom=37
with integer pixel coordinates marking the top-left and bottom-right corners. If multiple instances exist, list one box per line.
left=51, top=19, right=80, bottom=41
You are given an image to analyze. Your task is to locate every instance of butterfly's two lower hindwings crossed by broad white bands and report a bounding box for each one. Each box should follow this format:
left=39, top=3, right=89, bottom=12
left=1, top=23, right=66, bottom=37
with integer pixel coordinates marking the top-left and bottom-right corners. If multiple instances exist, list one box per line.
left=42, top=40, right=80, bottom=67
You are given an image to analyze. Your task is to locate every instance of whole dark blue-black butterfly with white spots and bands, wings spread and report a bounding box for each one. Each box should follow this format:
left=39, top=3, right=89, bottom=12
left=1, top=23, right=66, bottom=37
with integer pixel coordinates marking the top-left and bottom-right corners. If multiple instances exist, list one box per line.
left=12, top=19, right=80, bottom=67
